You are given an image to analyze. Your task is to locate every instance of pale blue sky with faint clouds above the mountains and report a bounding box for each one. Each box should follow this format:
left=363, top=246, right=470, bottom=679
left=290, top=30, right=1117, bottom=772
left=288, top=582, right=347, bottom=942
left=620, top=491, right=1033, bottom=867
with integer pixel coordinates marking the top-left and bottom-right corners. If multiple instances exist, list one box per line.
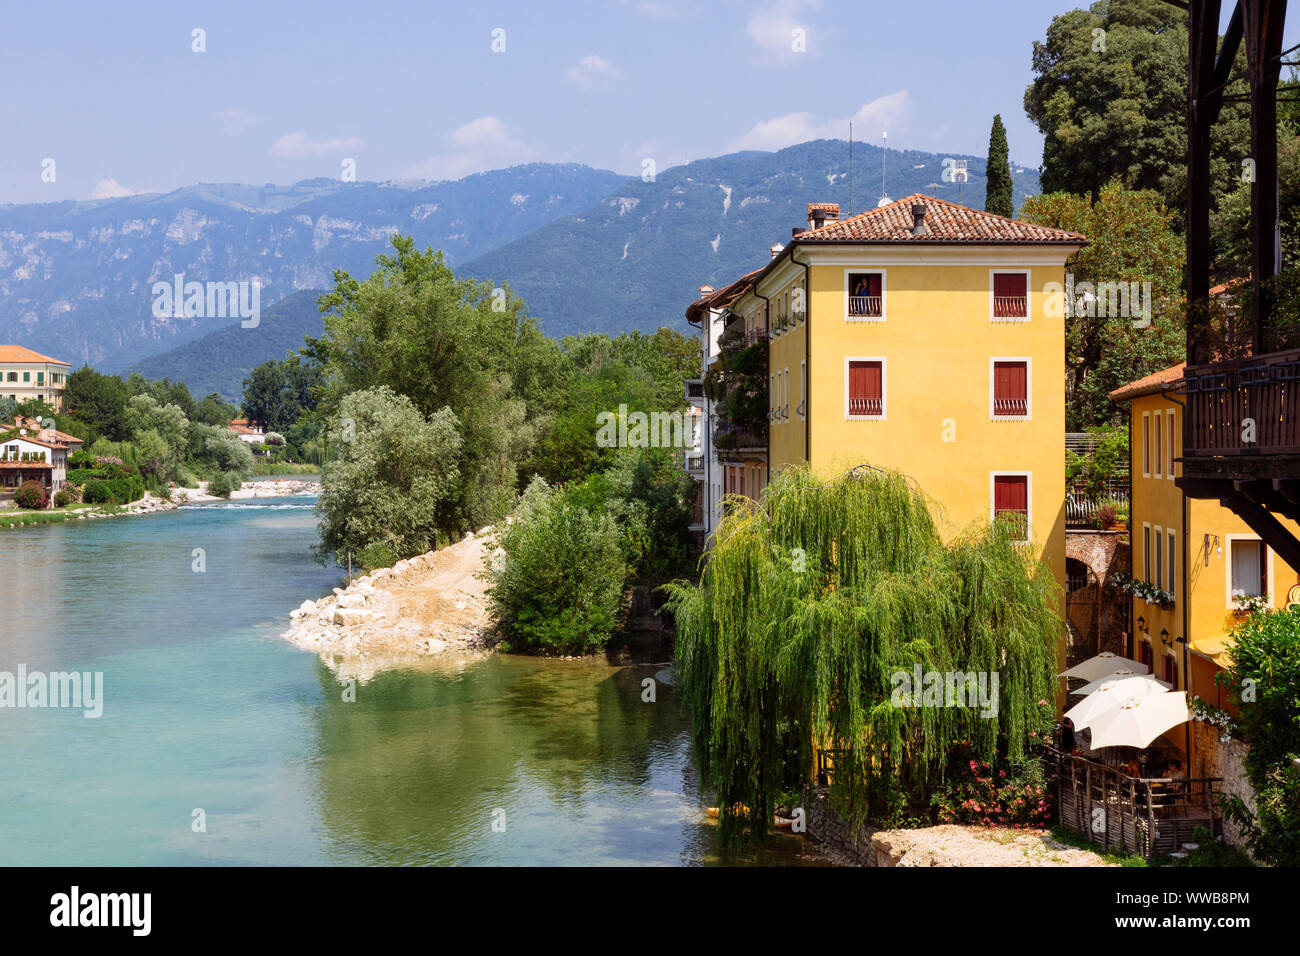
left=0, top=0, right=1294, bottom=203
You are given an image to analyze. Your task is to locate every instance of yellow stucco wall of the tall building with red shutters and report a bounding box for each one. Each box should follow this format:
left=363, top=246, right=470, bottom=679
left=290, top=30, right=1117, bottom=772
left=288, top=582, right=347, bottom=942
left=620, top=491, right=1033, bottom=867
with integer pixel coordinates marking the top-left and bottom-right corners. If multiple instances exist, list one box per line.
left=762, top=257, right=1065, bottom=581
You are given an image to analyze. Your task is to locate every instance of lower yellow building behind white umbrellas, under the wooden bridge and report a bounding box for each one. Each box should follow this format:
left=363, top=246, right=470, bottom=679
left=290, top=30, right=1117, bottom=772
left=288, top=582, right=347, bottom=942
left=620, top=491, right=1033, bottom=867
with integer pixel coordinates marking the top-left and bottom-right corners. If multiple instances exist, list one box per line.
left=1110, top=364, right=1300, bottom=706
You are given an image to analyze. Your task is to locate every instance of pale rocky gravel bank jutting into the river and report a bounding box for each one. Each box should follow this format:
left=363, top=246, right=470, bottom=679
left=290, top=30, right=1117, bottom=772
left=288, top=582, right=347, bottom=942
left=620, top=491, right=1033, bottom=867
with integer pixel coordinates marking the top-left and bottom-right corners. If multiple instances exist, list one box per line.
left=281, top=528, right=498, bottom=680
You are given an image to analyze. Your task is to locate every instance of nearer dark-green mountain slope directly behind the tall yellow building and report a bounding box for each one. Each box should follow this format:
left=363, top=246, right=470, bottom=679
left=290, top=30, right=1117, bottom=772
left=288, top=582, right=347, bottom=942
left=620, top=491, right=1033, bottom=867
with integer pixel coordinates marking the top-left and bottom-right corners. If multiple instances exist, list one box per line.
left=458, top=139, right=1037, bottom=334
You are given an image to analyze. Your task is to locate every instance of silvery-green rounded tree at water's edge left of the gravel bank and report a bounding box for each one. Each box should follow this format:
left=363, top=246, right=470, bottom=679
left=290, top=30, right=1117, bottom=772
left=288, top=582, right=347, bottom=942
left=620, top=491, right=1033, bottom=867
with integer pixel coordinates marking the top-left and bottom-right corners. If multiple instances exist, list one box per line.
left=316, top=385, right=463, bottom=562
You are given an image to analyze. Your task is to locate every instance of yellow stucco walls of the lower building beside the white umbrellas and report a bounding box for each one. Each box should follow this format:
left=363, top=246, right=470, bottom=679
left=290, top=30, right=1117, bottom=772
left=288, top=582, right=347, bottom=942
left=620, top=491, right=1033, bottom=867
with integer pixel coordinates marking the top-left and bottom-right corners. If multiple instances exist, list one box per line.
left=1131, top=394, right=1300, bottom=700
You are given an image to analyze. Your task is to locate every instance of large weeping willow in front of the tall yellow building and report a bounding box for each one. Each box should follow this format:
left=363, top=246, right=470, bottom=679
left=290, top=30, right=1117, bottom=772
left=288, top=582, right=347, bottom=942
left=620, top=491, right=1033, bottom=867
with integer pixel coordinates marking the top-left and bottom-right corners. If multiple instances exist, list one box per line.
left=668, top=468, right=1065, bottom=839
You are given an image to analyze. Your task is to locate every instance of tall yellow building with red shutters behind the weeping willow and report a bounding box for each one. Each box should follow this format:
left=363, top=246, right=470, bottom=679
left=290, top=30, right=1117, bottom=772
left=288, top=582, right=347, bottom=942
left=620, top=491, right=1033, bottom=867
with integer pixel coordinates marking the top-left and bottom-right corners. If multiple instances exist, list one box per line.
left=686, top=195, right=1086, bottom=595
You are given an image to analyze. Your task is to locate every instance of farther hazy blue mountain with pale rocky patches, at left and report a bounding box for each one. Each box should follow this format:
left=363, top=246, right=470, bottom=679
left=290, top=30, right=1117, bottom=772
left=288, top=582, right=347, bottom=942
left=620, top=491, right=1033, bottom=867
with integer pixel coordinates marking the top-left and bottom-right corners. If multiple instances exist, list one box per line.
left=0, top=164, right=624, bottom=371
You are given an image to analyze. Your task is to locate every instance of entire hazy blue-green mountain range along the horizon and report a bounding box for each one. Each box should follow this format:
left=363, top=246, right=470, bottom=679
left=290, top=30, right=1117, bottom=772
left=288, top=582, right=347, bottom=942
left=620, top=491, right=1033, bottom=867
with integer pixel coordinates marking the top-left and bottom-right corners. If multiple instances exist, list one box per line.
left=0, top=140, right=1037, bottom=398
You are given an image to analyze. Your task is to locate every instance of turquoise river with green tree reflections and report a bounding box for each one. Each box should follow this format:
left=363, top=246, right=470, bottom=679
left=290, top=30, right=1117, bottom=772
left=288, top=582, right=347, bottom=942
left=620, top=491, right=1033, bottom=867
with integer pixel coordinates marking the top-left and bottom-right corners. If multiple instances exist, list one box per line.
left=0, top=498, right=818, bottom=865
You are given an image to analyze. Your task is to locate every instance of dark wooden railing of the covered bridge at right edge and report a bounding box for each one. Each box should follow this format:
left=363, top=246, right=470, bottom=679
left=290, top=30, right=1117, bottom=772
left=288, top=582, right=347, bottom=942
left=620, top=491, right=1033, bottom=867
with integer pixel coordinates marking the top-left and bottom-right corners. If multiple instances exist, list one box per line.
left=1183, top=349, right=1300, bottom=458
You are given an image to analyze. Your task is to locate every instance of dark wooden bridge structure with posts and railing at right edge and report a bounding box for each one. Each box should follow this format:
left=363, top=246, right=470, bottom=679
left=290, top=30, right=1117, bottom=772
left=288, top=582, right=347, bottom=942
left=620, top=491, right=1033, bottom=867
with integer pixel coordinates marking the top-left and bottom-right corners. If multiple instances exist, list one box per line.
left=1166, top=0, right=1300, bottom=568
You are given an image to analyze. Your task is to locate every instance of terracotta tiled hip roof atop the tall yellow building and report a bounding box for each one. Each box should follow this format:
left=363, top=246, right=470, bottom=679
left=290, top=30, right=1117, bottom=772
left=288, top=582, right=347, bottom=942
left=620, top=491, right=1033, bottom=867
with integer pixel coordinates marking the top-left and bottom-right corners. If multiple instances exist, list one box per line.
left=793, top=193, right=1087, bottom=245
